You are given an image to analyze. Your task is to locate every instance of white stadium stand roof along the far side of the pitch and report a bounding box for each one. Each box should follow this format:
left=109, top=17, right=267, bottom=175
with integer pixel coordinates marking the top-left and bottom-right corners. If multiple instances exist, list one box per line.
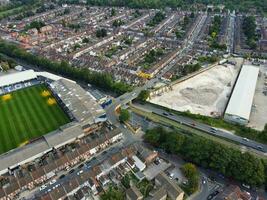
left=0, top=70, right=37, bottom=87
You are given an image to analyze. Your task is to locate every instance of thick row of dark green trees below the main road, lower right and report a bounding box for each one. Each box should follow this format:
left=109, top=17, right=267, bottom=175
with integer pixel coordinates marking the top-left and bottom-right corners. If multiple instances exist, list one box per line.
left=144, top=127, right=267, bottom=186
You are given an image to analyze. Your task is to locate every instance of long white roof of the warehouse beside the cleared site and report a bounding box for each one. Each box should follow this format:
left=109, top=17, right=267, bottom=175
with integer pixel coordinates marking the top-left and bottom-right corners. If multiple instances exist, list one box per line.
left=225, top=65, right=259, bottom=120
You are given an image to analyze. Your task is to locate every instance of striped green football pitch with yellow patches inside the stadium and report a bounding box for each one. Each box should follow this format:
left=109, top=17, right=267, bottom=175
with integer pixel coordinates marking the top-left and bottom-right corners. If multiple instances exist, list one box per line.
left=0, top=85, right=70, bottom=154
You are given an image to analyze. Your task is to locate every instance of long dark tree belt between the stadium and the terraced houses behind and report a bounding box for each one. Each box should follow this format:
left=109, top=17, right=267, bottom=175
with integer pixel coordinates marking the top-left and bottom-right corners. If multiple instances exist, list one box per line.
left=0, top=40, right=132, bottom=94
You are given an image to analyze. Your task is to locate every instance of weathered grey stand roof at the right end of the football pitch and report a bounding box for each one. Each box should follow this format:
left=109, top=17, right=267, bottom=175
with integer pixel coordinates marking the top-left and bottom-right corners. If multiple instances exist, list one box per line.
left=50, top=79, right=105, bottom=124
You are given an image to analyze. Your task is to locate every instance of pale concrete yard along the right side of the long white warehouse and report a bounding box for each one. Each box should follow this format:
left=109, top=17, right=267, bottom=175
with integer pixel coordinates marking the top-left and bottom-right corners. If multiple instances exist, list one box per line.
left=248, top=64, right=267, bottom=131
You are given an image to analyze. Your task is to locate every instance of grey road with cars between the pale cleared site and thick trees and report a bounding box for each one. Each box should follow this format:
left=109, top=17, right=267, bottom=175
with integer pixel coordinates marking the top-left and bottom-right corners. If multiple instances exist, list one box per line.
left=135, top=104, right=267, bottom=155
